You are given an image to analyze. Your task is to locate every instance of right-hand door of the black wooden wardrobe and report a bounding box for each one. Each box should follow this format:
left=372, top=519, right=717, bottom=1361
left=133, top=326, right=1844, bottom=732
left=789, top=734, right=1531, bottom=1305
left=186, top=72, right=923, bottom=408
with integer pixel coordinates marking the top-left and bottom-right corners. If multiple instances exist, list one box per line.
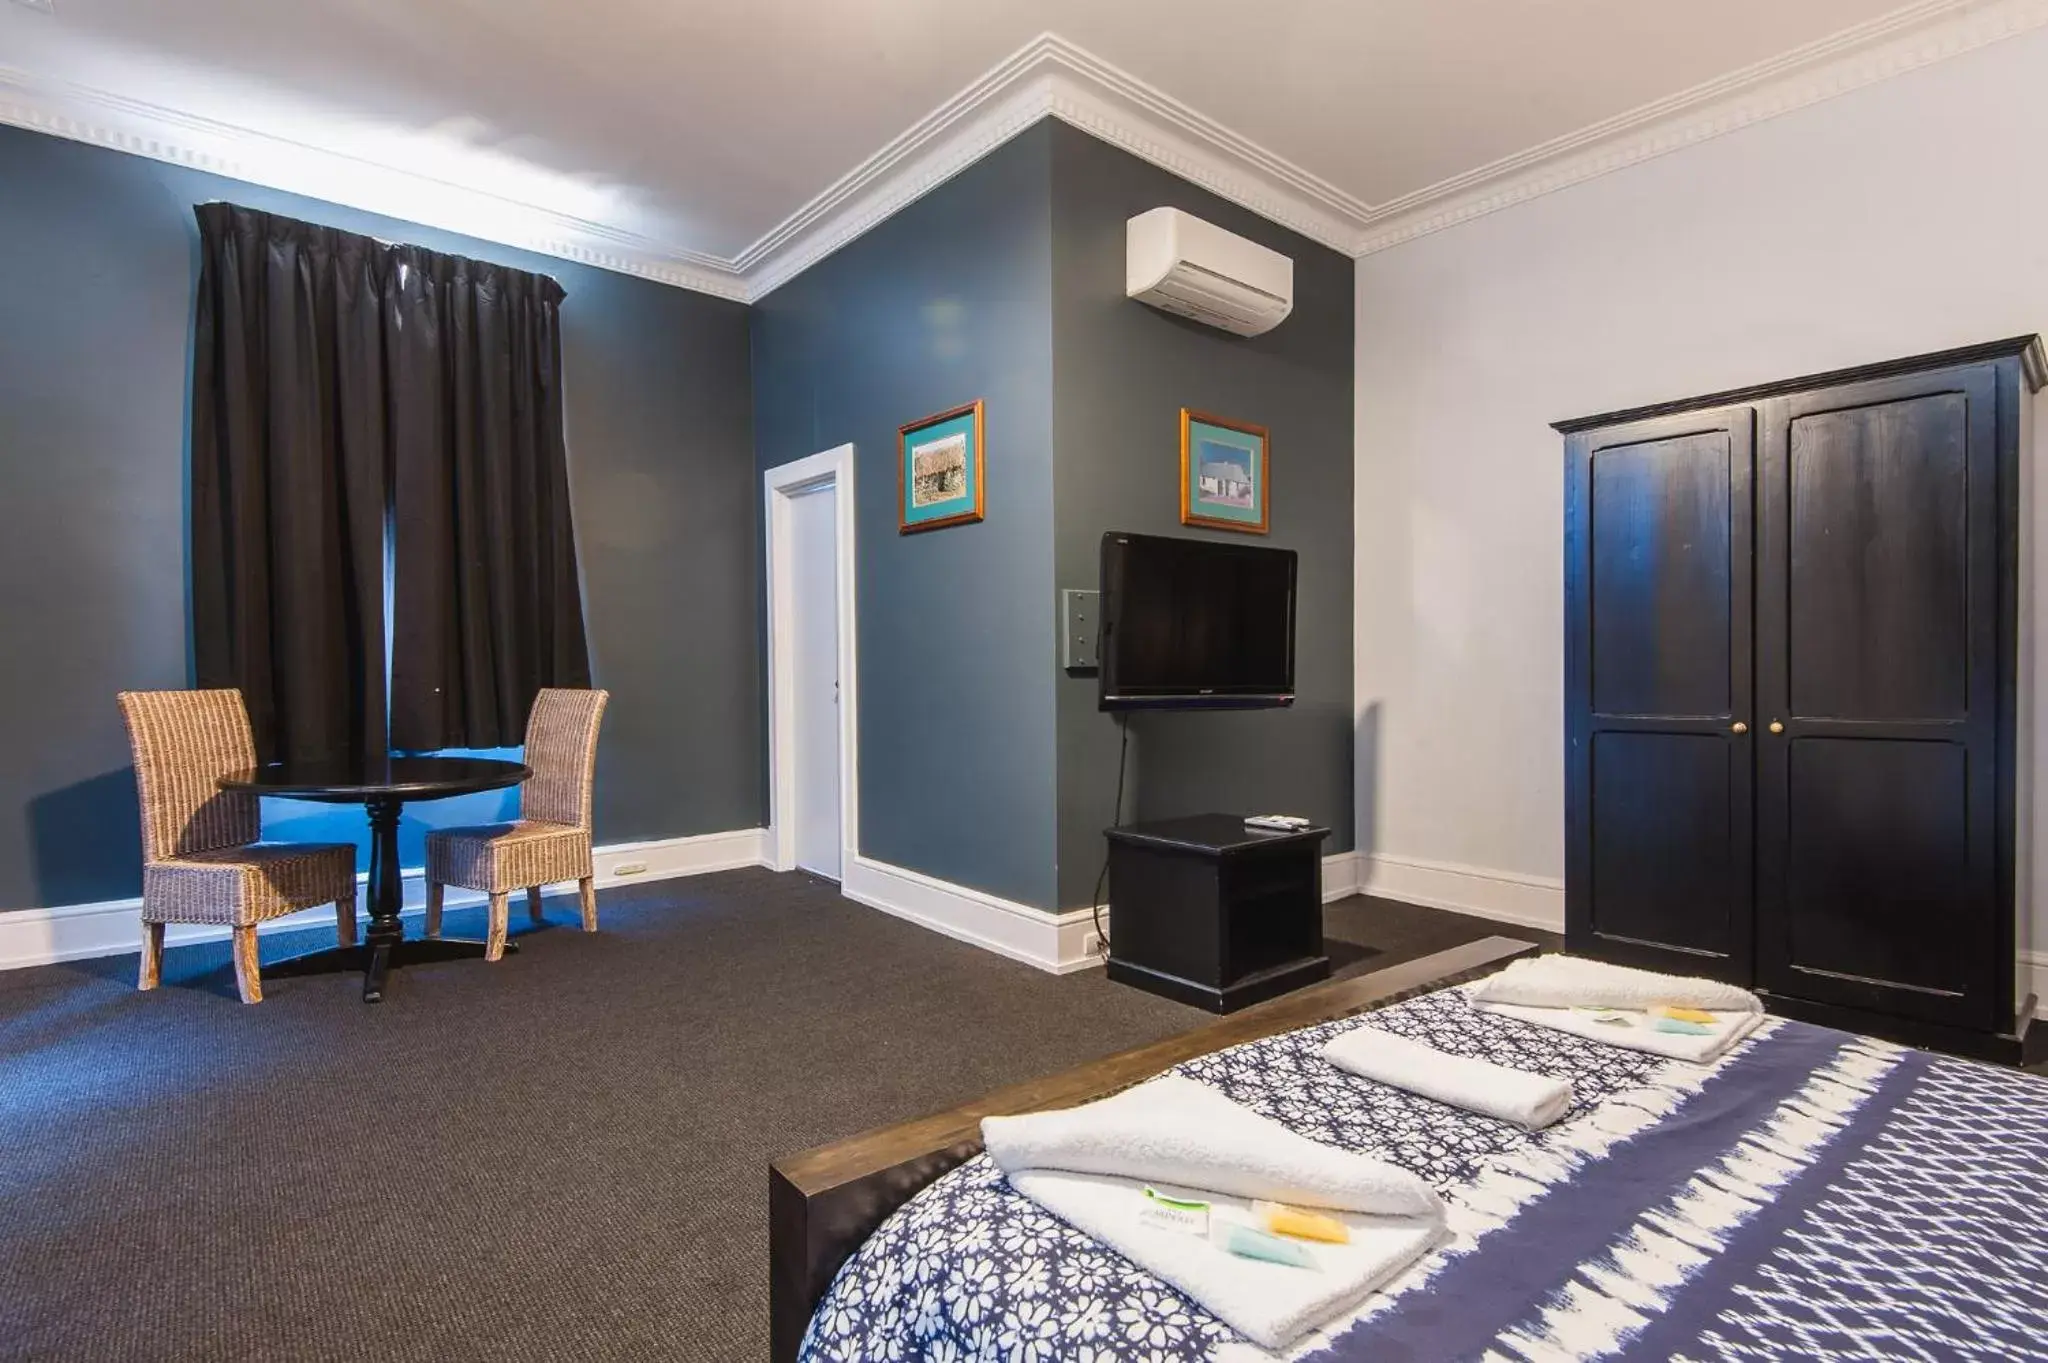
left=1757, top=364, right=2011, bottom=1027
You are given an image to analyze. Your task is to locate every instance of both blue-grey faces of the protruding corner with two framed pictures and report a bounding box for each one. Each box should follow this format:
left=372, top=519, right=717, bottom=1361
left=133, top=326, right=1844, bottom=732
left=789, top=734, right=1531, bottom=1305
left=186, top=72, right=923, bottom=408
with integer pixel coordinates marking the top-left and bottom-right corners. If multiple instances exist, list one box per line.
left=754, top=119, right=1352, bottom=909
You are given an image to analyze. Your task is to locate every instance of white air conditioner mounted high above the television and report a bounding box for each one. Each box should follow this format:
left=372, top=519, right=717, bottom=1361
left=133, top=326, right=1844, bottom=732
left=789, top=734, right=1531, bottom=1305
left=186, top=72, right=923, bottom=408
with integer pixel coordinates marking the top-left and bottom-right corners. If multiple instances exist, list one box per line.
left=1124, top=209, right=1294, bottom=336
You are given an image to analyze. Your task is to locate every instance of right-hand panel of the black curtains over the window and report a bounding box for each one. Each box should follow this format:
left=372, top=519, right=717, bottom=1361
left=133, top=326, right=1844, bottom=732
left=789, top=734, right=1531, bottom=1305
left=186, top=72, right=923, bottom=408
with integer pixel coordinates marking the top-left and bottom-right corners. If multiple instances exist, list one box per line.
left=389, top=246, right=590, bottom=749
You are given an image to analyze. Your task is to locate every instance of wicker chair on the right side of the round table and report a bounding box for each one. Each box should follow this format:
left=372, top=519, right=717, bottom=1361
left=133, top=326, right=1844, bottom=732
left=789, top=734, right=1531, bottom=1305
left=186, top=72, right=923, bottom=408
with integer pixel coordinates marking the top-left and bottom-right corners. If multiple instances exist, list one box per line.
left=426, top=688, right=610, bottom=960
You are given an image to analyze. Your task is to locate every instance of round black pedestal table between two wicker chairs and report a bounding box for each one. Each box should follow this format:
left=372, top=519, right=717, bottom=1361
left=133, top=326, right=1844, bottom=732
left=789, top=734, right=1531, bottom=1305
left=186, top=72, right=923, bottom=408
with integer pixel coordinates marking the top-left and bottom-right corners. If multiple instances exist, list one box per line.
left=221, top=757, right=532, bottom=1003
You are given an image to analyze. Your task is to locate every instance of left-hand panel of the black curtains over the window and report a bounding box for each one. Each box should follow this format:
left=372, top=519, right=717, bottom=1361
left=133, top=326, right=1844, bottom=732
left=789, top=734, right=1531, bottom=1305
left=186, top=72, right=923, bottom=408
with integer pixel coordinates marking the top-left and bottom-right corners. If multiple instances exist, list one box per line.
left=193, top=203, right=389, bottom=759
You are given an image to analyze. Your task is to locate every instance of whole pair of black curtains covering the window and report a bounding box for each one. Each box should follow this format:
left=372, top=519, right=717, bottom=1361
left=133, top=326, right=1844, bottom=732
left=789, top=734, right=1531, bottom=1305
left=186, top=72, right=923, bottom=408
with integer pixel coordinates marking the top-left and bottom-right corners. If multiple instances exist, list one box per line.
left=193, top=205, right=590, bottom=759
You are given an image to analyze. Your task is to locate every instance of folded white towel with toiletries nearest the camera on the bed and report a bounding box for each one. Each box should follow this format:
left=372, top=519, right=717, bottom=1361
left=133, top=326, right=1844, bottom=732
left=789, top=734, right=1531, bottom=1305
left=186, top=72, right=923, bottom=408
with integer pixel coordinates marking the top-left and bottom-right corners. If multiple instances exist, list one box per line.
left=981, top=1079, right=1444, bottom=1351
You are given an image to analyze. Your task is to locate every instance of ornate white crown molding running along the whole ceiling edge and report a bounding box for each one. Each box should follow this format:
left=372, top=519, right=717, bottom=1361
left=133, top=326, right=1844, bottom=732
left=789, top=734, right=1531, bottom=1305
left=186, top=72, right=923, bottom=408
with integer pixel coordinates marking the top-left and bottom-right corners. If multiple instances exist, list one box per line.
left=0, top=0, right=2048, bottom=301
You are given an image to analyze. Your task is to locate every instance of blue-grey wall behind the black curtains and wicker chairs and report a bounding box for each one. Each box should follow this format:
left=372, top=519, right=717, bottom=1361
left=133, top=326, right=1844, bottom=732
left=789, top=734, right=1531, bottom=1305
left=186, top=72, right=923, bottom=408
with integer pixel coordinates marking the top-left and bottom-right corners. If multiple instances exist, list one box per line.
left=0, top=129, right=766, bottom=909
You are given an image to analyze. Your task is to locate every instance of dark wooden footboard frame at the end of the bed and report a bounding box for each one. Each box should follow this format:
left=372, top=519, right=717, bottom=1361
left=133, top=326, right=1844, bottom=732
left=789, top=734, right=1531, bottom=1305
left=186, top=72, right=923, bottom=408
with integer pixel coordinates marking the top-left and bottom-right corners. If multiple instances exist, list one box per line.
left=768, top=937, right=1538, bottom=1363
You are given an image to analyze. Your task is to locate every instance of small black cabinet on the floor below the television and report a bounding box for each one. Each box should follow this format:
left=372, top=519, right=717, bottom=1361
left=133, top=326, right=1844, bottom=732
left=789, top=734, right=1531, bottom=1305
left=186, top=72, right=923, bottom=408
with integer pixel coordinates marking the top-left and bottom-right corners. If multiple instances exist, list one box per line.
left=1104, top=815, right=1329, bottom=1013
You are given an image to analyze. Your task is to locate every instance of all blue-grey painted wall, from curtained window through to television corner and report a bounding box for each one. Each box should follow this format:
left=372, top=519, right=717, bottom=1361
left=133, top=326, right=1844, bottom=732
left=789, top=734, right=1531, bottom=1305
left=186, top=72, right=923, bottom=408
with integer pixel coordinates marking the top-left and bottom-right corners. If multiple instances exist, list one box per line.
left=0, top=111, right=1352, bottom=909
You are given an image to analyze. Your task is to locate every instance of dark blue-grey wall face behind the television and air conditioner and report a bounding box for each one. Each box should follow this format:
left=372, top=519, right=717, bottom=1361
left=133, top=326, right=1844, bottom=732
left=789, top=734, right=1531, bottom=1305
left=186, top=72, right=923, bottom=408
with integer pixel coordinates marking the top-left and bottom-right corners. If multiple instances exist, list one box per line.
left=1044, top=125, right=1354, bottom=909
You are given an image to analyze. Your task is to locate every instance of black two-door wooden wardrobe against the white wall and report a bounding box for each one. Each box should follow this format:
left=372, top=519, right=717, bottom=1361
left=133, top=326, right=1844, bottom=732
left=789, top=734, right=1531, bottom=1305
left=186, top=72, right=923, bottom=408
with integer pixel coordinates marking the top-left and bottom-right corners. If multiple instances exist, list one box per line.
left=1556, top=336, right=2048, bottom=1056
